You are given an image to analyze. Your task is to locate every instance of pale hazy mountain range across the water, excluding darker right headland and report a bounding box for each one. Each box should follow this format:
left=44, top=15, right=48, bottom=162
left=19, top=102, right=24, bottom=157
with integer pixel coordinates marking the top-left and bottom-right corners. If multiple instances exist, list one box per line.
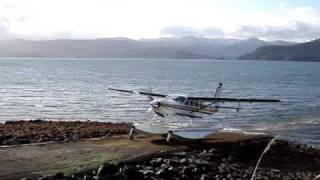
left=0, top=36, right=296, bottom=59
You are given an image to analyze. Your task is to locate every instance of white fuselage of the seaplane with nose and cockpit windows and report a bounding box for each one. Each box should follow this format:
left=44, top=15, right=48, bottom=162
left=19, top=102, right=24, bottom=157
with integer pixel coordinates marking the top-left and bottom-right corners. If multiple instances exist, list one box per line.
left=150, top=94, right=218, bottom=118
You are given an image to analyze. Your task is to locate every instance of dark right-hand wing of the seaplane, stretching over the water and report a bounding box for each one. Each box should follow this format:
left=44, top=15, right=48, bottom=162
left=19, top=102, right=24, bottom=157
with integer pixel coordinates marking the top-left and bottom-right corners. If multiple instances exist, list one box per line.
left=188, top=97, right=281, bottom=103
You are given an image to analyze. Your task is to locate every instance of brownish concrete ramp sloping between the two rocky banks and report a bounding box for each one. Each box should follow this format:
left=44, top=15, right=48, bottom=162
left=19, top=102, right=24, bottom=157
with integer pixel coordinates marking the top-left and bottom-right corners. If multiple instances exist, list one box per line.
left=0, top=132, right=266, bottom=179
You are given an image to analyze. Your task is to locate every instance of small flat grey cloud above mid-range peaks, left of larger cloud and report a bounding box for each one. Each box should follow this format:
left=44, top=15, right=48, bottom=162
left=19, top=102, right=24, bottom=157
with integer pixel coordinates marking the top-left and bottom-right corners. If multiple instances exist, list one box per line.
left=160, top=26, right=225, bottom=38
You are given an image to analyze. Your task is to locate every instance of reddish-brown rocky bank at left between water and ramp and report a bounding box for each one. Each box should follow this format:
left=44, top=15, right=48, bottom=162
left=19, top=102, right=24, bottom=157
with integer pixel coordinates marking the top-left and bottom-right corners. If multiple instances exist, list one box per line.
left=0, top=120, right=131, bottom=145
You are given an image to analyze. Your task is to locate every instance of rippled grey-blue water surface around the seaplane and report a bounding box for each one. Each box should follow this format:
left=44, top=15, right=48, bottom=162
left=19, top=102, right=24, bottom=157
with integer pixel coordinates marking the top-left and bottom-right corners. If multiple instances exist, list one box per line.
left=0, top=58, right=320, bottom=146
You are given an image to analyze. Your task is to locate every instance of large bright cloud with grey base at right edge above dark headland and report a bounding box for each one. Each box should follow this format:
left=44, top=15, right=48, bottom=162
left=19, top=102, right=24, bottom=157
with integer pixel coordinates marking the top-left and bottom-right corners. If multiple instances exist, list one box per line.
left=229, top=5, right=320, bottom=41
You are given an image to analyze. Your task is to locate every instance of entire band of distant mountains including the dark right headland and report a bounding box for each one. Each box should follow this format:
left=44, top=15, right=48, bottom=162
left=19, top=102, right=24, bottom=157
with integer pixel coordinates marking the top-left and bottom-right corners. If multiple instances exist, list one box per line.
left=0, top=36, right=320, bottom=61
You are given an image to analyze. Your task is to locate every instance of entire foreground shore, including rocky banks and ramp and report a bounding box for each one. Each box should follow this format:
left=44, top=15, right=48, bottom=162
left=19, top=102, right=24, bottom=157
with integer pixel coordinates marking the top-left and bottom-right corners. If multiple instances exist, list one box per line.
left=0, top=120, right=320, bottom=180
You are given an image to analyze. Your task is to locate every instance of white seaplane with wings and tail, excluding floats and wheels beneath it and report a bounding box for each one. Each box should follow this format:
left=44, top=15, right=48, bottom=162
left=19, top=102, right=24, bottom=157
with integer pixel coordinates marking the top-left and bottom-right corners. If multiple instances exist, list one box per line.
left=108, top=82, right=280, bottom=118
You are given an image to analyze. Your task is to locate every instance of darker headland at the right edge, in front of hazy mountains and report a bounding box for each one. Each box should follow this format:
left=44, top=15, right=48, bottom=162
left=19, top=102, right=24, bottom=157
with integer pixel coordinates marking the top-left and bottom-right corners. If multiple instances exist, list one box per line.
left=239, top=40, right=320, bottom=61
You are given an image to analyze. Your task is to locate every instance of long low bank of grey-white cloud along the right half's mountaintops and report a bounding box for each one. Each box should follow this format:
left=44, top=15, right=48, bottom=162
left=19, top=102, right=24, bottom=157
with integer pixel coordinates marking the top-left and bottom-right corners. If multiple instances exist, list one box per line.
left=161, top=20, right=320, bottom=41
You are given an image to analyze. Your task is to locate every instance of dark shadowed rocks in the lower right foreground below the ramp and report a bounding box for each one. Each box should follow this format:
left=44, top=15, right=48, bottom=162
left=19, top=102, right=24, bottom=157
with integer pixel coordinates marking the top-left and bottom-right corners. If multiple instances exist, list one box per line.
left=35, top=137, right=320, bottom=180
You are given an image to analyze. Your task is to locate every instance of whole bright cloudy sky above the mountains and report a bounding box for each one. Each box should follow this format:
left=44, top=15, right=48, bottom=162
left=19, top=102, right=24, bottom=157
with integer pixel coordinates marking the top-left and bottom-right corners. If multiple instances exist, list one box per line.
left=0, top=0, right=320, bottom=41
